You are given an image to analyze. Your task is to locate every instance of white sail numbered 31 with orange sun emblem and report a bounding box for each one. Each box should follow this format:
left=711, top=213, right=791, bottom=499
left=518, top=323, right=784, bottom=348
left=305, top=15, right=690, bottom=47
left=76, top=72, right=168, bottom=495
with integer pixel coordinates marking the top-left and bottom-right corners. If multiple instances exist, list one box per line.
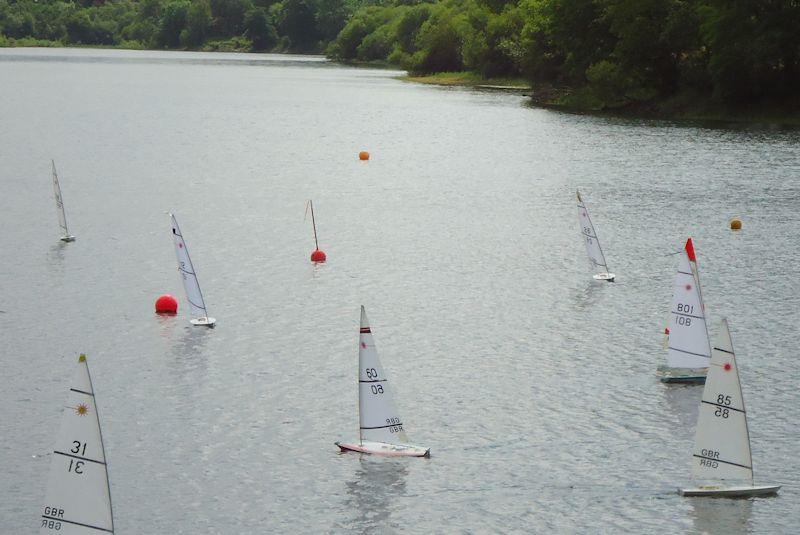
left=39, top=355, right=114, bottom=535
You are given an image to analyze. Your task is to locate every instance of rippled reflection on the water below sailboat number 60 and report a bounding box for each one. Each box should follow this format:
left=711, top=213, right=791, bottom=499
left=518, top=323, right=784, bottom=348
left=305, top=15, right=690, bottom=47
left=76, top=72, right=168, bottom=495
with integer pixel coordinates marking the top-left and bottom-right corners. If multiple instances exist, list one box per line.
left=345, top=455, right=408, bottom=533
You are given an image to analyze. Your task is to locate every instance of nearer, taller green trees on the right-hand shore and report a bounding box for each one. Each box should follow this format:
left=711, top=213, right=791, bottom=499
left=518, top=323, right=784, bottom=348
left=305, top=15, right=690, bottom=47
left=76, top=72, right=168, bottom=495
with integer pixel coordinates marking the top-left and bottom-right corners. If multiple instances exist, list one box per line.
left=328, top=0, right=800, bottom=107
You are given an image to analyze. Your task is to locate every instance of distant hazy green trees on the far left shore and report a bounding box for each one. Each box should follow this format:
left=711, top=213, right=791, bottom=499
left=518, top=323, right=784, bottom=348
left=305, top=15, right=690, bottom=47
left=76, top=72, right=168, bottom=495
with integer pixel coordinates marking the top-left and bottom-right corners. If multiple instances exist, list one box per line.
left=0, top=0, right=358, bottom=52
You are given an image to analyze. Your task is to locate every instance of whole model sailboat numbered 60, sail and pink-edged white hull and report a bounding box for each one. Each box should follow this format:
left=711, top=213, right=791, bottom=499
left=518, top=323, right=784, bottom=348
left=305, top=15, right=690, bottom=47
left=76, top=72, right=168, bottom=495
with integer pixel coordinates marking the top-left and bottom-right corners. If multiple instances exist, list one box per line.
left=336, top=306, right=430, bottom=457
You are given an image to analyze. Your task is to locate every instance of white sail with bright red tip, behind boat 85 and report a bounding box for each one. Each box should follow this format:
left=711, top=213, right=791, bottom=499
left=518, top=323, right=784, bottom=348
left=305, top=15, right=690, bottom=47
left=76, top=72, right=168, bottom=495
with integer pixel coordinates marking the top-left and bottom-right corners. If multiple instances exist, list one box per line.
left=667, top=238, right=711, bottom=369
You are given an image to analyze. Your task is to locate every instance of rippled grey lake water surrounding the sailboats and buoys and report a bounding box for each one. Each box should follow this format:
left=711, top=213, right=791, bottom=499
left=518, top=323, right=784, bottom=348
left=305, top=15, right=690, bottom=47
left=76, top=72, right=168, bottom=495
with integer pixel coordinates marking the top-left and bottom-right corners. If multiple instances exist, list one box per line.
left=0, top=49, right=800, bottom=534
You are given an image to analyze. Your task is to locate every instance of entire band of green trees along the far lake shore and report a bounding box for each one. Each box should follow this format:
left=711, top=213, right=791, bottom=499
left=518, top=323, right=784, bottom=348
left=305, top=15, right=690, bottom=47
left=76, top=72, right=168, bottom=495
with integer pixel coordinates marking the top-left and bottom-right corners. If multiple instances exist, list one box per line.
left=0, top=0, right=800, bottom=116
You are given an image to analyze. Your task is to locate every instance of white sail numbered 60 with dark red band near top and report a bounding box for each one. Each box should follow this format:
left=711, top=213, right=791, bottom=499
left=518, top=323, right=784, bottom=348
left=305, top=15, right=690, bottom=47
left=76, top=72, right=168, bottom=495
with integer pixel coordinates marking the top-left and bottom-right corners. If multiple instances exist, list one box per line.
left=358, top=306, right=409, bottom=444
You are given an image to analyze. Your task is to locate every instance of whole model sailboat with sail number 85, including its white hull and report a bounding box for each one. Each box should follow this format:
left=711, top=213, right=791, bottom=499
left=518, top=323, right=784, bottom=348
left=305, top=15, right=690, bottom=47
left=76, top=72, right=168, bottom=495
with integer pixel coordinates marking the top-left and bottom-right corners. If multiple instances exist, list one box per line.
left=679, top=319, right=780, bottom=497
